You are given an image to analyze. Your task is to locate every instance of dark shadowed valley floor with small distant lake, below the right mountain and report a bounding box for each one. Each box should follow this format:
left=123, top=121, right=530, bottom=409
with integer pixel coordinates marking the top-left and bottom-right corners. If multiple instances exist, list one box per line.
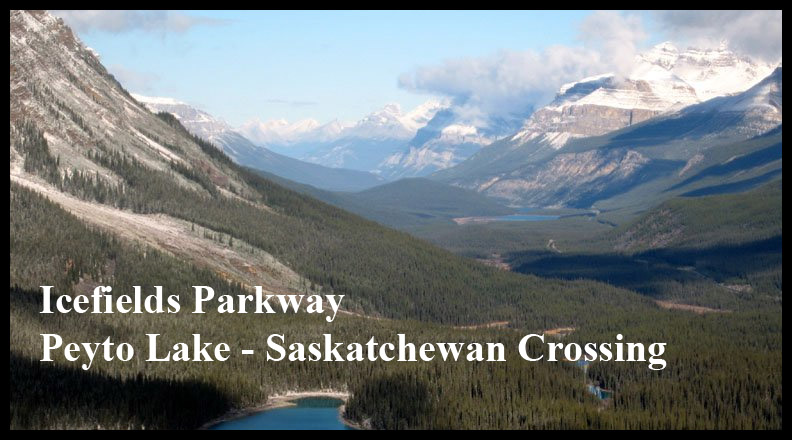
left=414, top=180, right=782, bottom=311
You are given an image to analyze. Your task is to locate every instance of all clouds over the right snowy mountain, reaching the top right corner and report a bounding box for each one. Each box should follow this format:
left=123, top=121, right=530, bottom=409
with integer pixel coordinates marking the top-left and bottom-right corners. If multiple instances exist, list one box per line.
left=398, top=11, right=781, bottom=125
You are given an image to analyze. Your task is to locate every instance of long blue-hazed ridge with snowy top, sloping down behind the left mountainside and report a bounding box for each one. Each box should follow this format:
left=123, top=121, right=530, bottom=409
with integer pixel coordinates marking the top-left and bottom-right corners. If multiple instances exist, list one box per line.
left=113, top=94, right=514, bottom=228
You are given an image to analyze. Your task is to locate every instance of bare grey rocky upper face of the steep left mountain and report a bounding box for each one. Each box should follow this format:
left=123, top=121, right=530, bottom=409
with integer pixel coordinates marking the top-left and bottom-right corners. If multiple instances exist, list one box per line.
left=10, top=11, right=251, bottom=192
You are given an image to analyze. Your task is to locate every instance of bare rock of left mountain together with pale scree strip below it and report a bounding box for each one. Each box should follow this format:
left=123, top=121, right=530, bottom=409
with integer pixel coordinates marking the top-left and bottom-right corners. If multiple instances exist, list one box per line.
left=9, top=7, right=306, bottom=289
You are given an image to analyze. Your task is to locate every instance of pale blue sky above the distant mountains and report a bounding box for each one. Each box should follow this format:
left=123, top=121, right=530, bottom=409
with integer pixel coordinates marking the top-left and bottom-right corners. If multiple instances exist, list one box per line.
left=56, top=11, right=780, bottom=126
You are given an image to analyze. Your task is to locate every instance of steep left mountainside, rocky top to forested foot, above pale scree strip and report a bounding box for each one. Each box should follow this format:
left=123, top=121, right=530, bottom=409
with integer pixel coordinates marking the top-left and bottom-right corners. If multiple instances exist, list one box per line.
left=11, top=11, right=656, bottom=330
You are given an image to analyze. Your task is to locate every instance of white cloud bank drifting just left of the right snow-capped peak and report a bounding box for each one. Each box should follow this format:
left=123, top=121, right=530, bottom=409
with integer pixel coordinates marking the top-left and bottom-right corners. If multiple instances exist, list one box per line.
left=398, top=12, right=646, bottom=122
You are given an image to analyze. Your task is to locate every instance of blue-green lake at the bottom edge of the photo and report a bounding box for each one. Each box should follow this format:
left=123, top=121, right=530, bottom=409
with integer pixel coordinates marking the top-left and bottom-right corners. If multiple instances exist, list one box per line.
left=209, top=397, right=353, bottom=430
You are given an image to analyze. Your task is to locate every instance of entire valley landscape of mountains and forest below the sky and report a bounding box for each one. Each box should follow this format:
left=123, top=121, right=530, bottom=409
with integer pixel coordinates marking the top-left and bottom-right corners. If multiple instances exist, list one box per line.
left=9, top=11, right=783, bottom=430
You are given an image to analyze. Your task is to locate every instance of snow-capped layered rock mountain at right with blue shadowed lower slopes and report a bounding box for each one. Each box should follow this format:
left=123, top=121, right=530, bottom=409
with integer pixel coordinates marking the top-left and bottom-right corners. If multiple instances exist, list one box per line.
left=434, top=43, right=781, bottom=206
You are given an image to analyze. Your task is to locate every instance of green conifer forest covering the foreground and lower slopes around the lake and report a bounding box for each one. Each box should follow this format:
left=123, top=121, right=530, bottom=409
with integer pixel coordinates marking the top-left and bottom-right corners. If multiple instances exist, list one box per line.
left=10, top=126, right=782, bottom=429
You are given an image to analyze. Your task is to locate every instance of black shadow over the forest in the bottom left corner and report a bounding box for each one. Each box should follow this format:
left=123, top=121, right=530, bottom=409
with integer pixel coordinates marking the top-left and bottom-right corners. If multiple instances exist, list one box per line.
left=10, top=350, right=231, bottom=429
